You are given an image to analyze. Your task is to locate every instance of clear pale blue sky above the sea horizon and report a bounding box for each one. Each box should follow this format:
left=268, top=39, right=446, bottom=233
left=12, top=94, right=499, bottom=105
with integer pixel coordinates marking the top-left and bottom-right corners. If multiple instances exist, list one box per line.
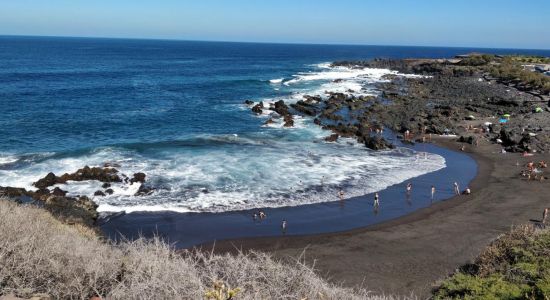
left=0, top=0, right=550, bottom=49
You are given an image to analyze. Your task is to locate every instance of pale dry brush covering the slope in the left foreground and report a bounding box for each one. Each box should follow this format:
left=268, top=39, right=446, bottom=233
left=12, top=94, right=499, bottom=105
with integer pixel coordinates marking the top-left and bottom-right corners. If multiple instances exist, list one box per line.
left=0, top=200, right=406, bottom=299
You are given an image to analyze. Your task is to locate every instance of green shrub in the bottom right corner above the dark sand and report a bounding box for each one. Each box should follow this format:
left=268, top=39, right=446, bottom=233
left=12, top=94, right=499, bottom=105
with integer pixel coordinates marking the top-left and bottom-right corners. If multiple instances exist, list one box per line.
left=434, top=225, right=550, bottom=299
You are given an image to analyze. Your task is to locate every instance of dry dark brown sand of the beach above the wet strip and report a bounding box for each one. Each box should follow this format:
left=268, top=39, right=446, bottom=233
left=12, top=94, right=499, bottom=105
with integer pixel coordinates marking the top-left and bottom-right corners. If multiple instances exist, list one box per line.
left=210, top=139, right=550, bottom=298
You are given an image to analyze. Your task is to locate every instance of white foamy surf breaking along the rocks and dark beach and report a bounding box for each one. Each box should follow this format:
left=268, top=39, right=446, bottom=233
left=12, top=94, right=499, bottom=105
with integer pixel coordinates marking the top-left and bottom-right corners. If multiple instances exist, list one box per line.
left=0, top=64, right=445, bottom=212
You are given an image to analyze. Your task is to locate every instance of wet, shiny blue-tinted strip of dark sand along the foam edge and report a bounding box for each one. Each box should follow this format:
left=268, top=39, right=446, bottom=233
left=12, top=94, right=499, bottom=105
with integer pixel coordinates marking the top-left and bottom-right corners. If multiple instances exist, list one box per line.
left=101, top=141, right=477, bottom=248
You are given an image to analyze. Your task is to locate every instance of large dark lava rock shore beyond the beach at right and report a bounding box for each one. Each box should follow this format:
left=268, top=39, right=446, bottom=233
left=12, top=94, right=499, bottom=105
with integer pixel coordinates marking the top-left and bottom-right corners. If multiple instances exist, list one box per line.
left=249, top=56, right=550, bottom=152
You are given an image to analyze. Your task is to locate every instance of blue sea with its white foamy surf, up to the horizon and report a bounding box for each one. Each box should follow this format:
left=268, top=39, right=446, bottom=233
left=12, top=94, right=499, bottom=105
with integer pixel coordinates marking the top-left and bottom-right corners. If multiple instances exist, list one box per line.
left=0, top=37, right=550, bottom=212
